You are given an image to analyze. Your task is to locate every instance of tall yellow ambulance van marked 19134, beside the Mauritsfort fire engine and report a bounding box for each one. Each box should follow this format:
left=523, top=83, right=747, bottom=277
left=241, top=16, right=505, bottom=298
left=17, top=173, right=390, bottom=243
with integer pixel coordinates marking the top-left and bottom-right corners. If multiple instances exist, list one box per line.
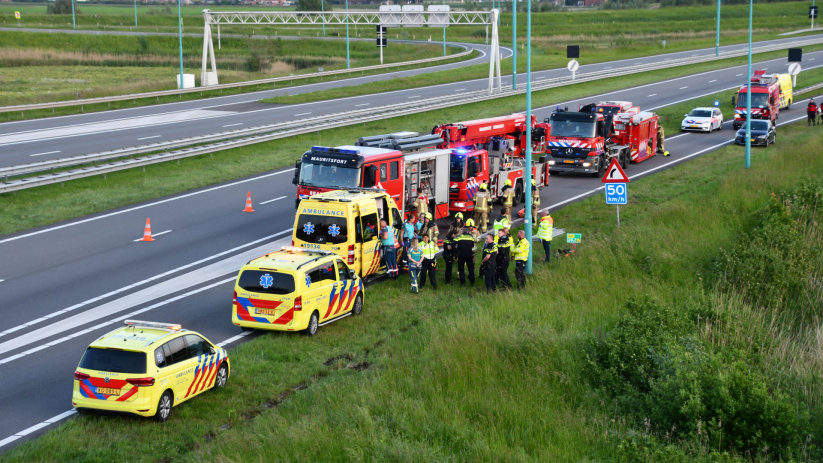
left=292, top=189, right=403, bottom=277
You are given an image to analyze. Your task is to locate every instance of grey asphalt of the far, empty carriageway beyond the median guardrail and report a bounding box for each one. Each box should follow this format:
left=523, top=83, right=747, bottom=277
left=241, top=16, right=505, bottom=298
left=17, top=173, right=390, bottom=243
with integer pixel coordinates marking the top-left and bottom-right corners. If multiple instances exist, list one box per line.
left=0, top=36, right=823, bottom=167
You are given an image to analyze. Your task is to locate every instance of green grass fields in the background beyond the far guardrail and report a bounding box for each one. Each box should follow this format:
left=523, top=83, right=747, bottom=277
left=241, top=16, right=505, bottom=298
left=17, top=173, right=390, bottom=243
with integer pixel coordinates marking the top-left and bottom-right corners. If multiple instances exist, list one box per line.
left=0, top=2, right=807, bottom=111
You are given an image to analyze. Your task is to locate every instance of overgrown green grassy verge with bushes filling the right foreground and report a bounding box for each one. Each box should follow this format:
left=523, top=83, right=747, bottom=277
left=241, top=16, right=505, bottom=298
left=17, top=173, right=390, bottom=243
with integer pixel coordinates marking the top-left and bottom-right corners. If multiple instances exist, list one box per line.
left=4, top=98, right=823, bottom=462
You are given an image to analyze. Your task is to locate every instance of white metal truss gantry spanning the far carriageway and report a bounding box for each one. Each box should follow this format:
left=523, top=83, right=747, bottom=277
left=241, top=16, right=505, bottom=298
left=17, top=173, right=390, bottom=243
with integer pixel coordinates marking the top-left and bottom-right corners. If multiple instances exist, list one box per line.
left=200, top=6, right=503, bottom=94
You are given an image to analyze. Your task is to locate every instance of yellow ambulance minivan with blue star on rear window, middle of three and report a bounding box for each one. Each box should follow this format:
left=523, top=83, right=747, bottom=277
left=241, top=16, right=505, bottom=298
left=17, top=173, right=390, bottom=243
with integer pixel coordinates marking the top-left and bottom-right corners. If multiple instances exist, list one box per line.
left=231, top=246, right=365, bottom=336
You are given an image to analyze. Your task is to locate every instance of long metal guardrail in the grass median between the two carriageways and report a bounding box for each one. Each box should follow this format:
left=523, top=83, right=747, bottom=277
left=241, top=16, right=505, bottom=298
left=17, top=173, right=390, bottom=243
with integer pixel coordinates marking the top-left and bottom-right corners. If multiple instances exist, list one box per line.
left=0, top=39, right=823, bottom=193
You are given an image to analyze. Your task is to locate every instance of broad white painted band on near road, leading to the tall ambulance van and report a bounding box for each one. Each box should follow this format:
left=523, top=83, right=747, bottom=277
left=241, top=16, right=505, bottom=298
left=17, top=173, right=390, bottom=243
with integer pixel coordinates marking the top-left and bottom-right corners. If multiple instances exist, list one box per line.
left=0, top=236, right=291, bottom=358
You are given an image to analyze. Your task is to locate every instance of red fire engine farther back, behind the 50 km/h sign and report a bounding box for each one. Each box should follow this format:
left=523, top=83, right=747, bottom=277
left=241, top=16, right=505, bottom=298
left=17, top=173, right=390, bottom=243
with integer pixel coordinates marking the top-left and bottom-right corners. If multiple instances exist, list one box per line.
left=548, top=104, right=666, bottom=177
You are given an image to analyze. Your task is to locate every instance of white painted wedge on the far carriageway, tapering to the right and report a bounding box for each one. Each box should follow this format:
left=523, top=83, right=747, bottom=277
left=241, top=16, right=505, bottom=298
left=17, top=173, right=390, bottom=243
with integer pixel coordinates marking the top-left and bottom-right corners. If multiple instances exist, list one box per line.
left=0, top=109, right=236, bottom=145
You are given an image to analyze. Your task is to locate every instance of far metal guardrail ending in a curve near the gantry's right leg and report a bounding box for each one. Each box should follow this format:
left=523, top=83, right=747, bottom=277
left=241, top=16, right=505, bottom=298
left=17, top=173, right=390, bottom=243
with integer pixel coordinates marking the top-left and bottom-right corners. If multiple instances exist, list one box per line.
left=0, top=44, right=472, bottom=113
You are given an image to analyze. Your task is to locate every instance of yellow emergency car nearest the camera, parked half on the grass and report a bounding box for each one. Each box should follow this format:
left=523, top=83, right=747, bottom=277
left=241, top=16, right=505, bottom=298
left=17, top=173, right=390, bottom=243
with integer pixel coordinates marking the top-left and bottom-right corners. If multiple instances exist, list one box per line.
left=71, top=320, right=229, bottom=421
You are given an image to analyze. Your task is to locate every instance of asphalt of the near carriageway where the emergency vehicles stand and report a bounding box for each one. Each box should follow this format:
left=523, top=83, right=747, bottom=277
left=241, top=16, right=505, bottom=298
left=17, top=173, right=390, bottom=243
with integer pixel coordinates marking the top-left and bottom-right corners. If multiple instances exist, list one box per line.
left=0, top=42, right=821, bottom=451
